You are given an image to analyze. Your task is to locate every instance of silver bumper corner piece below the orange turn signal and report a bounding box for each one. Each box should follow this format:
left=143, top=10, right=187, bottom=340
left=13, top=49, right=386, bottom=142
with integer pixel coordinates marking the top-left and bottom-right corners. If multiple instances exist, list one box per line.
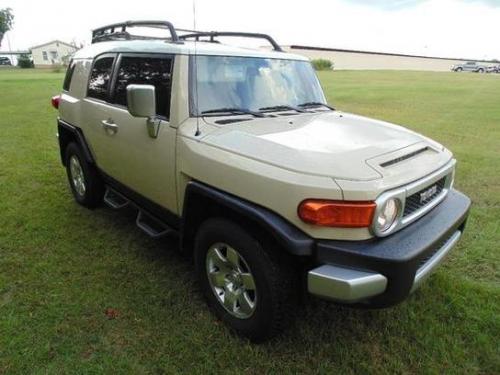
left=307, top=265, right=387, bottom=303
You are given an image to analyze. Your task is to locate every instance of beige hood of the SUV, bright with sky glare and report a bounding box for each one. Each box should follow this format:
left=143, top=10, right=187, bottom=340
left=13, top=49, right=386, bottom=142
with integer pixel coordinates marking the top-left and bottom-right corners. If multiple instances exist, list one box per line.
left=203, top=111, right=452, bottom=181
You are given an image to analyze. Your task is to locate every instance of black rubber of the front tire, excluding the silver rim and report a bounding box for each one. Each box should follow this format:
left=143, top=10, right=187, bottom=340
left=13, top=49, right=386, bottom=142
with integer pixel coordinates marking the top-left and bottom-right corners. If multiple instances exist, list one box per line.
left=194, top=218, right=296, bottom=342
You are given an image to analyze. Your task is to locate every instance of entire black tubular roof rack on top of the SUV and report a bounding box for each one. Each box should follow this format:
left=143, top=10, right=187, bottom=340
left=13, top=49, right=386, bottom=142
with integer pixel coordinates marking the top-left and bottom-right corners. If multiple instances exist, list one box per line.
left=92, top=21, right=283, bottom=52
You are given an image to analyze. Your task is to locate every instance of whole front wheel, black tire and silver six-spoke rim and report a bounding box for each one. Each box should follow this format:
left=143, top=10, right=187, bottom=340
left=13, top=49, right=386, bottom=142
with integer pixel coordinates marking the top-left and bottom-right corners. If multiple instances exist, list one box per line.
left=194, top=218, right=296, bottom=342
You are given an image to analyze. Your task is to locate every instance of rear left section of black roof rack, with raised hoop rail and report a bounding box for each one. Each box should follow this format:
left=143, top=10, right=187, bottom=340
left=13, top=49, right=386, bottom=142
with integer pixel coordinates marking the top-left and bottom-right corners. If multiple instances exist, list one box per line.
left=92, top=21, right=182, bottom=43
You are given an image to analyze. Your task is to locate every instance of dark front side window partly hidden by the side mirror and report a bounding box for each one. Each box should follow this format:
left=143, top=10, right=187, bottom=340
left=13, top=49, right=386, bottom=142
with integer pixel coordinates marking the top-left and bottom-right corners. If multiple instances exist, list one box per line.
left=113, top=56, right=173, bottom=119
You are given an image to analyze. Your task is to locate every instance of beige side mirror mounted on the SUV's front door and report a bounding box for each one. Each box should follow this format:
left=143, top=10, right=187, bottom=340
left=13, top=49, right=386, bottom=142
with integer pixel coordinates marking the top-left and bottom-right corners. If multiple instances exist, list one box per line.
left=127, top=85, right=161, bottom=138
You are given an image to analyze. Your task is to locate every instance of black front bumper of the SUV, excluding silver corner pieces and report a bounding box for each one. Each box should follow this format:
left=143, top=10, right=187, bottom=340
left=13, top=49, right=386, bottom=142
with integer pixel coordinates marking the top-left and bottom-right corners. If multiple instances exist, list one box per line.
left=315, top=189, right=471, bottom=307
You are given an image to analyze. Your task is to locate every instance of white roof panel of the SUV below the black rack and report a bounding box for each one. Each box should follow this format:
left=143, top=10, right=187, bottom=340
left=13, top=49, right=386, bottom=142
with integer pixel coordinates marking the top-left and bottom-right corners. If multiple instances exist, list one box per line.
left=73, top=40, right=308, bottom=61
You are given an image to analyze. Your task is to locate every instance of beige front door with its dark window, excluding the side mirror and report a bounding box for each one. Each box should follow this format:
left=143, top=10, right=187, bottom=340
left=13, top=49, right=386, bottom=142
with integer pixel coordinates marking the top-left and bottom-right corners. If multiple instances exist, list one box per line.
left=100, top=53, right=177, bottom=212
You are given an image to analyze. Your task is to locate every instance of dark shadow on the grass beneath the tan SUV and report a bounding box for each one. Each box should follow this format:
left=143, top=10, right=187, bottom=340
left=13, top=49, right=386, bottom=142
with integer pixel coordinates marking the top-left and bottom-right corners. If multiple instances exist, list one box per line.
left=84, top=203, right=397, bottom=349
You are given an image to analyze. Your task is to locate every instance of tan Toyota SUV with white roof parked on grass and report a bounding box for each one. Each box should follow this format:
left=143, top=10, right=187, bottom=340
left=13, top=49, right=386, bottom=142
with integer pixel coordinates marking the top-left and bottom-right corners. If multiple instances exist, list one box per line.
left=52, top=21, right=470, bottom=341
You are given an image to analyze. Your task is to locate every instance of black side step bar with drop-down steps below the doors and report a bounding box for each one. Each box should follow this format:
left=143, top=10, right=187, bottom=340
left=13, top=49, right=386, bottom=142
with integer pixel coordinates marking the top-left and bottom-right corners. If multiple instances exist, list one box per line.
left=104, top=187, right=175, bottom=238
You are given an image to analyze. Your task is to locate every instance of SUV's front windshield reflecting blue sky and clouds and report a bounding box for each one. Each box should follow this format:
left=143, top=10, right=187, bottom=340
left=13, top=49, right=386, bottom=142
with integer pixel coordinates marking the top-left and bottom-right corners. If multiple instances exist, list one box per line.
left=191, top=56, right=326, bottom=116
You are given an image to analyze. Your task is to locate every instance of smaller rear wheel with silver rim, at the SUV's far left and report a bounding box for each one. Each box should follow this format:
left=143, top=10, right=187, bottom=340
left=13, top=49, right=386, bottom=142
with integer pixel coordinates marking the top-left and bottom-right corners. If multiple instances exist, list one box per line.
left=65, top=142, right=104, bottom=208
